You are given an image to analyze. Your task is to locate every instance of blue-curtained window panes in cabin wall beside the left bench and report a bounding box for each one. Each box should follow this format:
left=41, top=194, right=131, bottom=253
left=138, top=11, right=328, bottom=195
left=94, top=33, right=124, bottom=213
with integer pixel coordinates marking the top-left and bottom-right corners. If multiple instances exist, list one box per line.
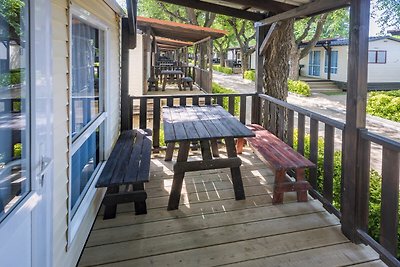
left=70, top=16, right=105, bottom=216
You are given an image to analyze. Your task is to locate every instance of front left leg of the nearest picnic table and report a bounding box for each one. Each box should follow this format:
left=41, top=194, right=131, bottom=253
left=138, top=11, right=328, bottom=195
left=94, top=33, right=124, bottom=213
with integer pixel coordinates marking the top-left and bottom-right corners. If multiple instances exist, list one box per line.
left=168, top=141, right=190, bottom=210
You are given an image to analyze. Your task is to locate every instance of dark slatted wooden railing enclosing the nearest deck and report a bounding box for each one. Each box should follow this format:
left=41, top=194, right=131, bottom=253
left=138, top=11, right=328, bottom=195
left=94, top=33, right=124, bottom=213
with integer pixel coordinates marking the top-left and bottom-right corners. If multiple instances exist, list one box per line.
left=130, top=94, right=400, bottom=266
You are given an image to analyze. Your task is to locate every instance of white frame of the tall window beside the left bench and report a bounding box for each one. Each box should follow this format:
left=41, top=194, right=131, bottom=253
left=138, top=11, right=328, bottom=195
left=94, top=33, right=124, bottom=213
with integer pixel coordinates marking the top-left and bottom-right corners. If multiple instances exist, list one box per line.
left=67, top=4, right=111, bottom=246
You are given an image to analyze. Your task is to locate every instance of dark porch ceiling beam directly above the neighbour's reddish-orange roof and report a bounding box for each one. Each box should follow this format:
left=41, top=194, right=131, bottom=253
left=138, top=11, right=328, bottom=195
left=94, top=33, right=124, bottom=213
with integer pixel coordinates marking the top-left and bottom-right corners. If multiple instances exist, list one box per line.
left=159, top=0, right=265, bottom=21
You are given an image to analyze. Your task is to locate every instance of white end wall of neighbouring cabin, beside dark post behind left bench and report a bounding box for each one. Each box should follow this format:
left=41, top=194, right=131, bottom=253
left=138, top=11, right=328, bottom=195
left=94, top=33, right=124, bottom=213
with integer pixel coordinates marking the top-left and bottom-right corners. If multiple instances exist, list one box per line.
left=129, top=34, right=144, bottom=96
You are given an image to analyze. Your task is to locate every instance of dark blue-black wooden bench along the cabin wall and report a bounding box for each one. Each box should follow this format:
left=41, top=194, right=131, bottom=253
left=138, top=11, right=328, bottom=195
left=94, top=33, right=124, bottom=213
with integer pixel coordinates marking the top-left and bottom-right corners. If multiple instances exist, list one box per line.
left=96, top=129, right=152, bottom=219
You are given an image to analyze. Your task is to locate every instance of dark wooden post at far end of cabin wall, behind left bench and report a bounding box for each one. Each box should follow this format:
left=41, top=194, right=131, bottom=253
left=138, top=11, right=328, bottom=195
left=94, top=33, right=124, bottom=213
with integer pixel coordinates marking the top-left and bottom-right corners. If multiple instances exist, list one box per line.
left=121, top=18, right=136, bottom=131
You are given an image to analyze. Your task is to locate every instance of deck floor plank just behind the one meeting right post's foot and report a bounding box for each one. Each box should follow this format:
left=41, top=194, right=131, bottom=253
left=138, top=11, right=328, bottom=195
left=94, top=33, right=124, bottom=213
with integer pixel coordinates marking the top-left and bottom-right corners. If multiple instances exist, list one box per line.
left=82, top=213, right=340, bottom=263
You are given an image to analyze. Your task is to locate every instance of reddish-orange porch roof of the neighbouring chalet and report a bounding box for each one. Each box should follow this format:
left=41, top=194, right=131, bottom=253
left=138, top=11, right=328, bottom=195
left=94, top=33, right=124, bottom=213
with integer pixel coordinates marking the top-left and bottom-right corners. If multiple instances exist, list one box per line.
left=137, top=16, right=227, bottom=43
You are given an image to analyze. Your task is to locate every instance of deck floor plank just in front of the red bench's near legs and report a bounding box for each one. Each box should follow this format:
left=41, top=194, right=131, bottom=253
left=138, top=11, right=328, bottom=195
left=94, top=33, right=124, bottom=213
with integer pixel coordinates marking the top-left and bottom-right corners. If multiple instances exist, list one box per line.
left=86, top=203, right=326, bottom=247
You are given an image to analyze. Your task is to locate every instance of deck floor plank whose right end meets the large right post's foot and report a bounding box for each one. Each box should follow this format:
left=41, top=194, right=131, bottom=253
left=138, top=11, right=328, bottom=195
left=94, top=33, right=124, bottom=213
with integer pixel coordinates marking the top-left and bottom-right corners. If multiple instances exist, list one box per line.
left=80, top=226, right=348, bottom=267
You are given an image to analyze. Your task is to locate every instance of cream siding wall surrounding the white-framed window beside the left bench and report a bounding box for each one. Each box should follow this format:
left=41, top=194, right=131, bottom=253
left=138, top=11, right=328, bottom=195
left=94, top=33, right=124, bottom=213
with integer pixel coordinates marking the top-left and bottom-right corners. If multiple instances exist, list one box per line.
left=52, top=0, right=120, bottom=266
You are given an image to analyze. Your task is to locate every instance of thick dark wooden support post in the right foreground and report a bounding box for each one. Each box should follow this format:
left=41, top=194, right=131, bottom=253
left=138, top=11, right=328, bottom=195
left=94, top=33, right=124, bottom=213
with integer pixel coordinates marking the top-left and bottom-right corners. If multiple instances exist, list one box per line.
left=341, top=0, right=370, bottom=242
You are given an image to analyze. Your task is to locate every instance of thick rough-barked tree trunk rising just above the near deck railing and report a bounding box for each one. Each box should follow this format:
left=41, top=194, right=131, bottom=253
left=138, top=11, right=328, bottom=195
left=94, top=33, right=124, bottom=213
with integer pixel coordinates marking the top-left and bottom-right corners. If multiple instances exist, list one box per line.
left=264, top=19, right=294, bottom=100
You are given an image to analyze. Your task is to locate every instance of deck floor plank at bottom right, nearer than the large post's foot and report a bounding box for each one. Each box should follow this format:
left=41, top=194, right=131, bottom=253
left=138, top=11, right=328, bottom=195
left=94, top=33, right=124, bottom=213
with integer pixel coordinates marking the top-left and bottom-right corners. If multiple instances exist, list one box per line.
left=223, top=243, right=379, bottom=267
